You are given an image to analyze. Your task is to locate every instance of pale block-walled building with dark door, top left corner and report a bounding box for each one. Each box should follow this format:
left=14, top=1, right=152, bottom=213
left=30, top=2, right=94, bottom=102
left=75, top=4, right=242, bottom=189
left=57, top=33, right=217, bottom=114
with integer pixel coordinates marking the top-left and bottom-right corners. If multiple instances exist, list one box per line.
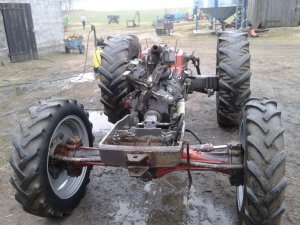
left=0, top=0, right=64, bottom=63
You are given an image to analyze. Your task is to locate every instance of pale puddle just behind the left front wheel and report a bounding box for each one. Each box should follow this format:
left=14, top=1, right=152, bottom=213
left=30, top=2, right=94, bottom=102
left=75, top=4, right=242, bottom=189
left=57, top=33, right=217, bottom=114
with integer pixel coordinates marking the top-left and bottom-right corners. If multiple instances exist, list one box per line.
left=88, top=111, right=113, bottom=134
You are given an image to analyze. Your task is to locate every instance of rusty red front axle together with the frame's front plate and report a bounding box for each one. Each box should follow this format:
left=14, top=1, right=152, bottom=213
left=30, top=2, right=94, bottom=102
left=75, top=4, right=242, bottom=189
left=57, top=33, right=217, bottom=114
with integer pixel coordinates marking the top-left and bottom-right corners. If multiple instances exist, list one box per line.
left=52, top=136, right=244, bottom=186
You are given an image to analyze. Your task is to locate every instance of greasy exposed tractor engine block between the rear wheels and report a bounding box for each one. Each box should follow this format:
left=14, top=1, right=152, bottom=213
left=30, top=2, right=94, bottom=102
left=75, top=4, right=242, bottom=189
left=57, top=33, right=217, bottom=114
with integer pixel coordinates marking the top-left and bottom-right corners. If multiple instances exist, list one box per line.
left=127, top=45, right=185, bottom=126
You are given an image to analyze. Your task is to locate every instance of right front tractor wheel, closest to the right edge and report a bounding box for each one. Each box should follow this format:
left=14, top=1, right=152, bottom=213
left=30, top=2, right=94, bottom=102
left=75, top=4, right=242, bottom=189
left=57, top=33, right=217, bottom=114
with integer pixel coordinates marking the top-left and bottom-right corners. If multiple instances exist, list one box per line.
left=237, top=99, right=287, bottom=225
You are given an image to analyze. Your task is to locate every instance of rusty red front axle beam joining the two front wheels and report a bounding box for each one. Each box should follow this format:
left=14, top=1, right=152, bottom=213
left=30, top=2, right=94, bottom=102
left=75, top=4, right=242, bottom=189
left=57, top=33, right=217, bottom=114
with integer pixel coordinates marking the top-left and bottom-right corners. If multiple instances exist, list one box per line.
left=55, top=138, right=244, bottom=180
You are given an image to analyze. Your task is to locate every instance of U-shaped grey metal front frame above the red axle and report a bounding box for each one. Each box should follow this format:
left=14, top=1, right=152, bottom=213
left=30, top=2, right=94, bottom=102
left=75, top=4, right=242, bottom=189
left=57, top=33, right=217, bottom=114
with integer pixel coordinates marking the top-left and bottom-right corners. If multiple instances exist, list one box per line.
left=99, top=115, right=185, bottom=167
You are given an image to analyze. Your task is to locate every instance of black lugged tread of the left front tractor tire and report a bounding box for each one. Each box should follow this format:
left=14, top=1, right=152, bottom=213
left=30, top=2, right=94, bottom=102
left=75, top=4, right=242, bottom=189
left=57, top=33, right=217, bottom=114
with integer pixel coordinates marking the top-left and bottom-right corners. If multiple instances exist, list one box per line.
left=9, top=99, right=92, bottom=217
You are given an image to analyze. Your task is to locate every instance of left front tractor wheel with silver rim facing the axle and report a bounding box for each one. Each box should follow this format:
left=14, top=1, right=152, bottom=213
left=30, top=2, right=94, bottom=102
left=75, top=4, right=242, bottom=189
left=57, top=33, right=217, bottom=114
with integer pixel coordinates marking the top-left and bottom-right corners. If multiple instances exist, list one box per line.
left=10, top=99, right=93, bottom=217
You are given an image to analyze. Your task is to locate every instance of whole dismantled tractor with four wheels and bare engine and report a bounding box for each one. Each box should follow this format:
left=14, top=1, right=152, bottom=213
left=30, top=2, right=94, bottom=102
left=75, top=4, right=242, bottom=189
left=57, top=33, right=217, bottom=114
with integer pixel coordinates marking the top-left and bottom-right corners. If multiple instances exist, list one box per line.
left=10, top=32, right=287, bottom=225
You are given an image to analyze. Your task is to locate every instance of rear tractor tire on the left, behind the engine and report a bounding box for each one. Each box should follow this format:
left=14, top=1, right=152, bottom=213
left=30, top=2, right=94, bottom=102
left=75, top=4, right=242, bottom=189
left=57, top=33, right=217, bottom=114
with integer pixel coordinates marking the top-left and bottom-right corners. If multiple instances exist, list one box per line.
left=99, top=35, right=140, bottom=123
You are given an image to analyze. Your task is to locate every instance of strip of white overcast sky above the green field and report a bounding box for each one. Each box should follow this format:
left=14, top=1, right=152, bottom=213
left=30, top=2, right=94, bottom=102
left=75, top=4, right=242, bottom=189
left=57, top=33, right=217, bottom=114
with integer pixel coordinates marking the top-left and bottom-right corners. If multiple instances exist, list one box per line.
left=83, top=0, right=193, bottom=11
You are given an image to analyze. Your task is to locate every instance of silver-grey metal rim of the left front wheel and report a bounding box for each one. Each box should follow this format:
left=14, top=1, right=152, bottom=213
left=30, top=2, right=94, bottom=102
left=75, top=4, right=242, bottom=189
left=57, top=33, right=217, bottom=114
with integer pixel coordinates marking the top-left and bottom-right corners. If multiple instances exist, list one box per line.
left=47, top=115, right=89, bottom=199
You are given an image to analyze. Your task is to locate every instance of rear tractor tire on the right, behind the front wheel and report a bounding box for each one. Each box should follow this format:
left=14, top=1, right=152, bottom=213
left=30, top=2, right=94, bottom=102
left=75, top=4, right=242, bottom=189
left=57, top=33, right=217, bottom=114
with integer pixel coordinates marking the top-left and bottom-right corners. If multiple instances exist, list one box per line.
left=216, top=31, right=251, bottom=127
